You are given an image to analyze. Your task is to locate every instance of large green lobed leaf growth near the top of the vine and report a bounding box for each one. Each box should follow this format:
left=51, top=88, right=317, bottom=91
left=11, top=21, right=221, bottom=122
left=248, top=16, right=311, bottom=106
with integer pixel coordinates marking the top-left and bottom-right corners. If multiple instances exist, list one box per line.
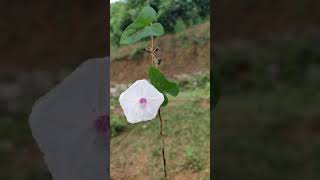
left=120, top=6, right=164, bottom=44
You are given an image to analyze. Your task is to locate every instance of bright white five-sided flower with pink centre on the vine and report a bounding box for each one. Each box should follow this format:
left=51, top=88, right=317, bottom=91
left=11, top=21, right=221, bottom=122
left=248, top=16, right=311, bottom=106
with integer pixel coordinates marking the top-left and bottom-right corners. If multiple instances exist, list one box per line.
left=119, top=79, right=164, bottom=123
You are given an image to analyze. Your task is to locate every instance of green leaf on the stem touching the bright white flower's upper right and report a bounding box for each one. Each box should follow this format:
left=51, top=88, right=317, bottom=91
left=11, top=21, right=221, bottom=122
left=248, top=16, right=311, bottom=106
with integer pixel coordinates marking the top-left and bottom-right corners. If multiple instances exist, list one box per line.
left=149, top=67, right=179, bottom=96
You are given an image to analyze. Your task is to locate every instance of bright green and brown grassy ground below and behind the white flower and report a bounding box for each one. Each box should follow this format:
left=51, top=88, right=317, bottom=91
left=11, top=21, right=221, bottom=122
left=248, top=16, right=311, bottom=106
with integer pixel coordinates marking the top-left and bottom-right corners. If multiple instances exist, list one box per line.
left=110, top=74, right=210, bottom=179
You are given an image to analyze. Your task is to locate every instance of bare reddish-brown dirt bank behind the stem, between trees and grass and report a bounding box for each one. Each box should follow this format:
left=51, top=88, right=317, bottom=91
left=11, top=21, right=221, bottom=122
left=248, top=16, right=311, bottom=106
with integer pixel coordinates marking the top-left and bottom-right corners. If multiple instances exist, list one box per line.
left=110, top=23, right=210, bottom=84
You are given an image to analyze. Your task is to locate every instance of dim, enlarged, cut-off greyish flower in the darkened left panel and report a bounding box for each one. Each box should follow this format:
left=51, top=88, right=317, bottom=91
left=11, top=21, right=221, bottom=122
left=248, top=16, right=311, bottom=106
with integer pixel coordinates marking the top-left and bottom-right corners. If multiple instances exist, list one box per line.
left=29, top=58, right=110, bottom=180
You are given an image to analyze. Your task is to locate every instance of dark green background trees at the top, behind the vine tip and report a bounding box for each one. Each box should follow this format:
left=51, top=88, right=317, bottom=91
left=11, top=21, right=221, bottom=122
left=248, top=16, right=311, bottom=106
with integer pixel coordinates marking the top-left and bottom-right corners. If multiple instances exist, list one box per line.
left=110, top=0, right=210, bottom=47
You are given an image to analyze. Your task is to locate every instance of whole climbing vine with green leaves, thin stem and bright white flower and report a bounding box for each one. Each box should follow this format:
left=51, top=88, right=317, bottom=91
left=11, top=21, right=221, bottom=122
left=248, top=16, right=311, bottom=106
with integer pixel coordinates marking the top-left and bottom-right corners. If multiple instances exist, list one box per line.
left=119, top=2, right=179, bottom=178
